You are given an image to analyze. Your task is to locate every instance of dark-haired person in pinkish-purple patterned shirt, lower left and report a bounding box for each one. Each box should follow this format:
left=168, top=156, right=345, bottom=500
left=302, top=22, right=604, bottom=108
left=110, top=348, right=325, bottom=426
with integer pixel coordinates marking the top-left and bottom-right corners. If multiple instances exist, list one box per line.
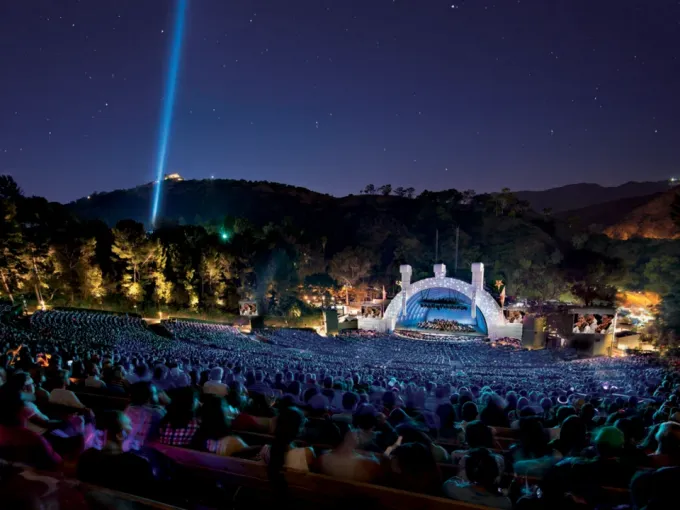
left=125, top=381, right=166, bottom=451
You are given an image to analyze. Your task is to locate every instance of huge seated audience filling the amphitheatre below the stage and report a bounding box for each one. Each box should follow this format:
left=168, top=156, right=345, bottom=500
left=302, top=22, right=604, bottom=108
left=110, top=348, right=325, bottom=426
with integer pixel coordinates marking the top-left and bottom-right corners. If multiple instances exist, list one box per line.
left=0, top=312, right=680, bottom=508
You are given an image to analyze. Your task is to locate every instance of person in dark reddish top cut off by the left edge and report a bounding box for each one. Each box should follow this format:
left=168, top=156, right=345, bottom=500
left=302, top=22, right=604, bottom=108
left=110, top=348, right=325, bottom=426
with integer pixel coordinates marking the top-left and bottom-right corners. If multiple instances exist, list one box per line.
left=0, top=388, right=62, bottom=470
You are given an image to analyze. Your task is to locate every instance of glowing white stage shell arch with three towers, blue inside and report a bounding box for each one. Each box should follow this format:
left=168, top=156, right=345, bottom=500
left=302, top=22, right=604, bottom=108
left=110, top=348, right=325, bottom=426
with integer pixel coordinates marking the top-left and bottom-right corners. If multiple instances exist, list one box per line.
left=383, top=264, right=521, bottom=339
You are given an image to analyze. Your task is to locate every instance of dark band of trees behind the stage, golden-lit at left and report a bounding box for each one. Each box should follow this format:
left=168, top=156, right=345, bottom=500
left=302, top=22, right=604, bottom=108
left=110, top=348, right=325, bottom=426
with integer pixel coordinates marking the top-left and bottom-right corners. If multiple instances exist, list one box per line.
left=0, top=176, right=680, bottom=344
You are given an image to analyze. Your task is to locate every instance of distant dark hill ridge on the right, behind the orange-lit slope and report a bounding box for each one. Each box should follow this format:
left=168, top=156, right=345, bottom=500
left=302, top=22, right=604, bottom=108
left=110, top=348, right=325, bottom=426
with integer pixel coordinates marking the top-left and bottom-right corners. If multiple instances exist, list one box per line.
left=513, top=181, right=668, bottom=213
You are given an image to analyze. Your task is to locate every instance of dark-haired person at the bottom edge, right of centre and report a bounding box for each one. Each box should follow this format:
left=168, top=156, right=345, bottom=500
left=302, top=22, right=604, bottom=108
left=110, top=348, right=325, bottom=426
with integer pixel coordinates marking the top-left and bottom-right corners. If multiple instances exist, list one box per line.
left=443, top=448, right=512, bottom=510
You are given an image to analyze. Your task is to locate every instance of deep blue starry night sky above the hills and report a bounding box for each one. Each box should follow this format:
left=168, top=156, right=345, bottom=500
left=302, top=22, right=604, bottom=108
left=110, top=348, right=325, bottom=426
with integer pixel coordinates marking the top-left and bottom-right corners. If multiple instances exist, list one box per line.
left=0, top=0, right=680, bottom=201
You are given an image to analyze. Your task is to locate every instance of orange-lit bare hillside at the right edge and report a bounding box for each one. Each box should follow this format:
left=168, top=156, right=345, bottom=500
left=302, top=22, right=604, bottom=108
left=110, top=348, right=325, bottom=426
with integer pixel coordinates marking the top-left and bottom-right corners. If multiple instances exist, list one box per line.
left=605, top=189, right=680, bottom=241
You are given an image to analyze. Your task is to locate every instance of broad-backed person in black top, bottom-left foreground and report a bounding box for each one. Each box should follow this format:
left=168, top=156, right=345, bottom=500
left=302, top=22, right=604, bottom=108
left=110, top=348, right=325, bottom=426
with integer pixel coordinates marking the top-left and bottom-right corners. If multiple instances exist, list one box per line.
left=77, top=411, right=174, bottom=500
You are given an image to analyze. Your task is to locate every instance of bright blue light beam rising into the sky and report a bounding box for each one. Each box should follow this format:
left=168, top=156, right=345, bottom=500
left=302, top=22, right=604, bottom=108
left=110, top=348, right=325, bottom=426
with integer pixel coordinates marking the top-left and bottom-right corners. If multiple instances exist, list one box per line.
left=151, top=0, right=188, bottom=226
